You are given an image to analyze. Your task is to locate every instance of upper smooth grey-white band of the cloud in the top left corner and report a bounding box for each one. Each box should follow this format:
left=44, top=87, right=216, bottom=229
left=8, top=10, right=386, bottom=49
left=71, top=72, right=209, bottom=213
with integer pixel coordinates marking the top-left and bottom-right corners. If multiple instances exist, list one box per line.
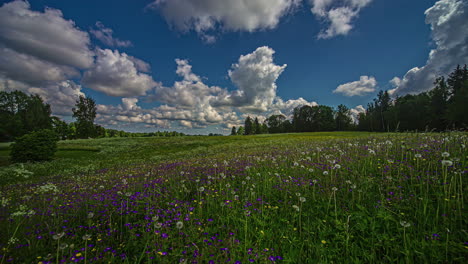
left=0, top=0, right=93, bottom=68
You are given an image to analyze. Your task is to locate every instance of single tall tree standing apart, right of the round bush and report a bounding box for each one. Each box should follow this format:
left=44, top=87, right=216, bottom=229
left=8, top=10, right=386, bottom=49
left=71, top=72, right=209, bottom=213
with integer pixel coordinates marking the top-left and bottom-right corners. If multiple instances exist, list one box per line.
left=72, top=96, right=96, bottom=138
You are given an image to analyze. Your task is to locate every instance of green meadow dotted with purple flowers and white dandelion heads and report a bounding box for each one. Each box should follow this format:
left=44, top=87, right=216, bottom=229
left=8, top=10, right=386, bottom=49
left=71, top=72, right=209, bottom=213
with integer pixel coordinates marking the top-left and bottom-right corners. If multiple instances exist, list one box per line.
left=0, top=133, right=468, bottom=263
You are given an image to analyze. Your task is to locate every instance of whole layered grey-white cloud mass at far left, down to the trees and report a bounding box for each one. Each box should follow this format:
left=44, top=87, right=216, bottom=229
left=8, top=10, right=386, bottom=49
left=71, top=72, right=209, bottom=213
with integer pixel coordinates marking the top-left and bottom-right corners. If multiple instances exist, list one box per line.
left=0, top=1, right=94, bottom=115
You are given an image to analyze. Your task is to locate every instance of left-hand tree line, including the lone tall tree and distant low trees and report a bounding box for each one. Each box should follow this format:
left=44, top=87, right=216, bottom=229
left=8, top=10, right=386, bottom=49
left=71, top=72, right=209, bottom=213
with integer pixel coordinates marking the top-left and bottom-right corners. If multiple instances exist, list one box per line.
left=0, top=91, right=185, bottom=142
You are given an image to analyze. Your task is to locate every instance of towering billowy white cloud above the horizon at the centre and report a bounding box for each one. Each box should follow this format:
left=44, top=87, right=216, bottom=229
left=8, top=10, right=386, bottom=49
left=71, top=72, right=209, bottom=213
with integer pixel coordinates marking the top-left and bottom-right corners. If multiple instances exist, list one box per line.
left=148, top=47, right=317, bottom=128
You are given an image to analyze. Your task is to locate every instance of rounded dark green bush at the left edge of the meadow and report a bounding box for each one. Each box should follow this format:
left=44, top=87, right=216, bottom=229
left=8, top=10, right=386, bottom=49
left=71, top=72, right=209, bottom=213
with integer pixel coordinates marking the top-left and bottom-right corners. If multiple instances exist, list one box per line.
left=10, top=129, right=58, bottom=162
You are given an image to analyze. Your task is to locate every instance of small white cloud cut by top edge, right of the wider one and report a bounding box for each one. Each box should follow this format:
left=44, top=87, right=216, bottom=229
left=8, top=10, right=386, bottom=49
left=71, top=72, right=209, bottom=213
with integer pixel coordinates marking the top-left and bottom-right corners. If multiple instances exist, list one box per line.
left=309, top=0, right=372, bottom=39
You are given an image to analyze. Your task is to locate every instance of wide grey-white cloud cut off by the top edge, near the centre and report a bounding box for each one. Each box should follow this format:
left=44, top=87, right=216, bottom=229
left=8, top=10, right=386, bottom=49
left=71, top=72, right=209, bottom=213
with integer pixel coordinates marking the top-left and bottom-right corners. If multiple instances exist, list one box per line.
left=149, top=0, right=302, bottom=42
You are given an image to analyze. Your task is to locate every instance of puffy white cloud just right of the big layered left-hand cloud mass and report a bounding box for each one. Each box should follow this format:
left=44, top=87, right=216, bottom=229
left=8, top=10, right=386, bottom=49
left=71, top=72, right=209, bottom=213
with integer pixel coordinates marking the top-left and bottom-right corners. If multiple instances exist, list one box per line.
left=82, top=49, right=157, bottom=97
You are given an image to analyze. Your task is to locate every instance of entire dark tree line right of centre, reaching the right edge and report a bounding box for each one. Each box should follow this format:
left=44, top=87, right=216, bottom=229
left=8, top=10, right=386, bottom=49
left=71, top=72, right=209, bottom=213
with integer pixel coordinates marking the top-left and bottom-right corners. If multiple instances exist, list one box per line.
left=231, top=65, right=468, bottom=135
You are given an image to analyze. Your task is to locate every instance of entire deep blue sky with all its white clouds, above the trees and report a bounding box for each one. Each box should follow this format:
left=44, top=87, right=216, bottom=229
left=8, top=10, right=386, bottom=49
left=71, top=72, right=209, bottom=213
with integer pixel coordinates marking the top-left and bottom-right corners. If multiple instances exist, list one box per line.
left=0, top=0, right=468, bottom=134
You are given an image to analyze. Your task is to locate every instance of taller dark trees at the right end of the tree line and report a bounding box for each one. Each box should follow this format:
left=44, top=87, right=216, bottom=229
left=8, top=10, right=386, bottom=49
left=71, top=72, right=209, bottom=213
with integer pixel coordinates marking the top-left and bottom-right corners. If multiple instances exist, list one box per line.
left=358, top=65, right=468, bottom=132
